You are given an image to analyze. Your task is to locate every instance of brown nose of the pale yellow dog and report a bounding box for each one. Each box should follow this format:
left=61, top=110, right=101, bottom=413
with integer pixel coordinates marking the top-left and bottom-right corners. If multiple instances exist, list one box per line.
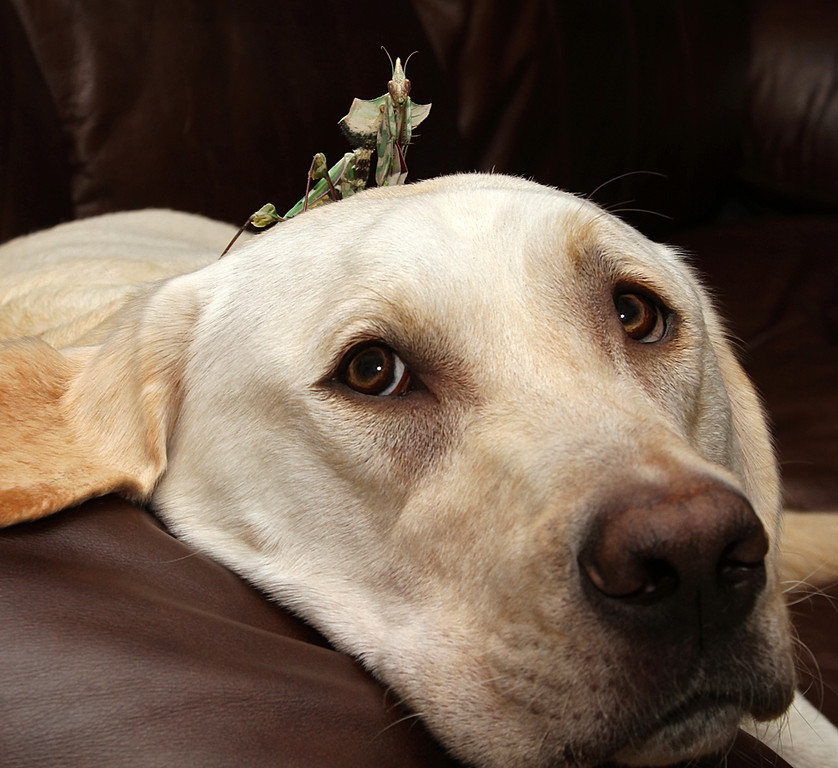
left=579, top=480, right=768, bottom=636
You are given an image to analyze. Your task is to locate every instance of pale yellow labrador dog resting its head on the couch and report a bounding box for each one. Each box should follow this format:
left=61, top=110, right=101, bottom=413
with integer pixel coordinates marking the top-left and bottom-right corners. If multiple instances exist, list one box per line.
left=0, top=175, right=838, bottom=768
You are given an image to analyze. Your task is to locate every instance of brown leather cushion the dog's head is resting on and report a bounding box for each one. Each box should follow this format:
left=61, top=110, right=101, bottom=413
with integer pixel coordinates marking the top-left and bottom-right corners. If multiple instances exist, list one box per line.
left=0, top=497, right=796, bottom=768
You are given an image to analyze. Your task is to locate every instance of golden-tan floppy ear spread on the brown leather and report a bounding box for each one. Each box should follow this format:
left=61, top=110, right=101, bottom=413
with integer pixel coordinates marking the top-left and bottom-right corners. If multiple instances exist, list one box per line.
left=0, top=281, right=196, bottom=526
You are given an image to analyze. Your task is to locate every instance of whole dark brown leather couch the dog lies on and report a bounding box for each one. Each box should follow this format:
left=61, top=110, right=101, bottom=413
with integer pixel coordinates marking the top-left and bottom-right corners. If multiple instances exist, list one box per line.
left=0, top=0, right=838, bottom=768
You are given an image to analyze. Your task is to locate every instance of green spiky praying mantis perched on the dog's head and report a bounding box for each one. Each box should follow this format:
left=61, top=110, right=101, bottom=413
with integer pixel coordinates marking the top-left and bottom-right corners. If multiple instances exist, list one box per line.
left=219, top=48, right=431, bottom=258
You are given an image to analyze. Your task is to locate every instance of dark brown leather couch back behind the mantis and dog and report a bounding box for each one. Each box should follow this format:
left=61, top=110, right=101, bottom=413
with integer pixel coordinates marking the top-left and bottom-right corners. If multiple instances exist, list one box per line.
left=0, top=0, right=838, bottom=239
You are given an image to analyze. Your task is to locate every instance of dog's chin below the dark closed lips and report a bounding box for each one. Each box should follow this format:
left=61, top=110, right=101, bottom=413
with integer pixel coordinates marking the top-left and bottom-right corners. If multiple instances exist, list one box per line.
left=613, top=702, right=742, bottom=768
